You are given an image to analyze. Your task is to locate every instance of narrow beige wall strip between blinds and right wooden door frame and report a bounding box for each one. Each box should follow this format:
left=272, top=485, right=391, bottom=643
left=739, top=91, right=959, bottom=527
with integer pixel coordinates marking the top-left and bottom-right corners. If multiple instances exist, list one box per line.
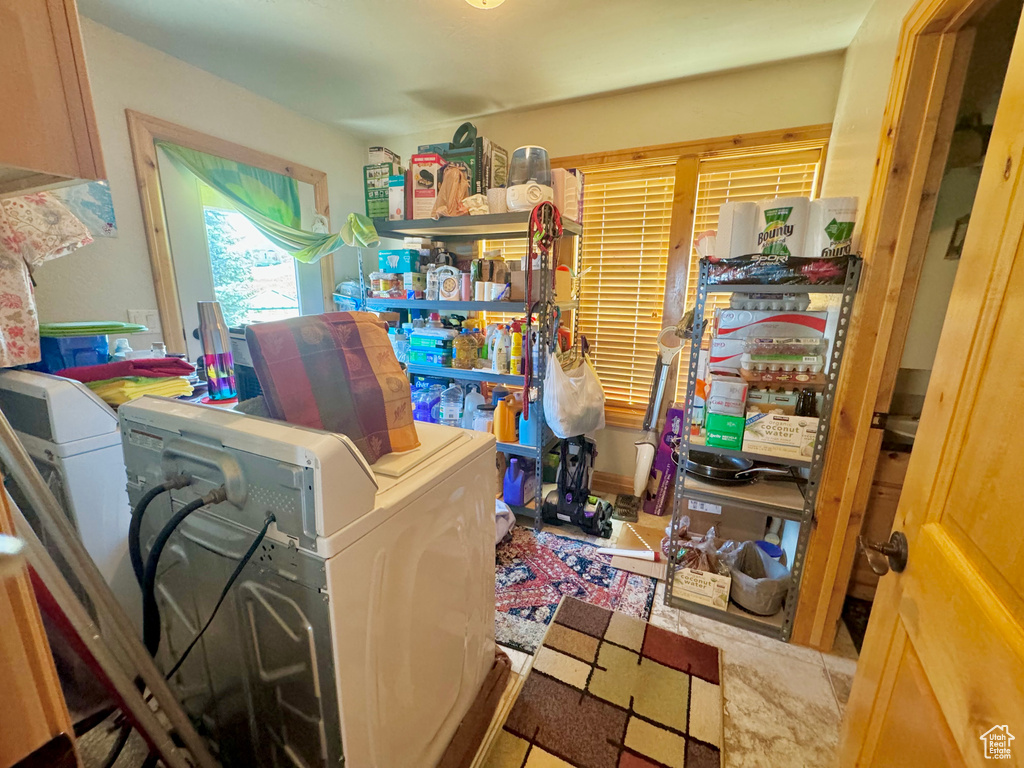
left=822, top=0, right=915, bottom=210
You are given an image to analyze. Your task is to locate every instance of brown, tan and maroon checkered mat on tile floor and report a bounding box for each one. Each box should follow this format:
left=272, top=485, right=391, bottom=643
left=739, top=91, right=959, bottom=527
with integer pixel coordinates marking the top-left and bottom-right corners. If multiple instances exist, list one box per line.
left=484, top=597, right=722, bottom=768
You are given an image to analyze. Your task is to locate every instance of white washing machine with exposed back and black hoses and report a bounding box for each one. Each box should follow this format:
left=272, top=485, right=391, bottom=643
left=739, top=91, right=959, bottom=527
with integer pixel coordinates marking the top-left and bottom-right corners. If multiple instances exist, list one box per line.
left=120, top=397, right=496, bottom=768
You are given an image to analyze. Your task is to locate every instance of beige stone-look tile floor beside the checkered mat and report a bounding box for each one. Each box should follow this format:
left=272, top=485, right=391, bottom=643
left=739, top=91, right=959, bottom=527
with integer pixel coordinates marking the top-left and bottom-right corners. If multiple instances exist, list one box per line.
left=505, top=515, right=857, bottom=768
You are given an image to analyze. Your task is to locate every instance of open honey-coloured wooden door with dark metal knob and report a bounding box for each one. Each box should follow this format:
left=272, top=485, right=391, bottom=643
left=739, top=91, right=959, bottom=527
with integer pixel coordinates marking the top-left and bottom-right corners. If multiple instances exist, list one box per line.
left=841, top=12, right=1024, bottom=768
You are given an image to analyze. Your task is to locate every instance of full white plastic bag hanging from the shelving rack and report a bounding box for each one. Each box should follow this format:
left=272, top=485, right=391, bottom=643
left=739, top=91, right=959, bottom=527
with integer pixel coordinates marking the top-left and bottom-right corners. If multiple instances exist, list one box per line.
left=544, top=354, right=604, bottom=439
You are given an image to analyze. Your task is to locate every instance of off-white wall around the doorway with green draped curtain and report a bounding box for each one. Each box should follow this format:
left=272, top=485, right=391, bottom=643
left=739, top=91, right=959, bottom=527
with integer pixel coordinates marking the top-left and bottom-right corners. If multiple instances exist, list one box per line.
left=36, top=18, right=366, bottom=344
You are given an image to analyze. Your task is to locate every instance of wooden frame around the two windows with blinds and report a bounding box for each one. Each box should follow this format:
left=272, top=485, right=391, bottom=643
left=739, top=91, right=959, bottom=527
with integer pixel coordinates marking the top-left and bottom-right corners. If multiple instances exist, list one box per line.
left=551, top=123, right=831, bottom=429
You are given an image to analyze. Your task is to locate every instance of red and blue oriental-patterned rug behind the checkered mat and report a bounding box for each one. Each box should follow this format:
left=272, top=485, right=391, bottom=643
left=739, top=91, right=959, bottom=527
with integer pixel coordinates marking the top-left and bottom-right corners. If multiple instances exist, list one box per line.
left=495, top=526, right=657, bottom=653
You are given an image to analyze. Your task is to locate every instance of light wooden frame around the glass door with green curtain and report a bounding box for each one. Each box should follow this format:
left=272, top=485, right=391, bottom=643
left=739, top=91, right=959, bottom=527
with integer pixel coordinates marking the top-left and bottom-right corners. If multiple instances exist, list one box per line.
left=125, top=110, right=334, bottom=353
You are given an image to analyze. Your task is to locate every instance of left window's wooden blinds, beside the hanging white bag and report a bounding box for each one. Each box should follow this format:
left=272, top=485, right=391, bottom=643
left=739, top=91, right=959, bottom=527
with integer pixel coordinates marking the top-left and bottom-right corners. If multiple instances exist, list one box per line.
left=580, top=158, right=676, bottom=414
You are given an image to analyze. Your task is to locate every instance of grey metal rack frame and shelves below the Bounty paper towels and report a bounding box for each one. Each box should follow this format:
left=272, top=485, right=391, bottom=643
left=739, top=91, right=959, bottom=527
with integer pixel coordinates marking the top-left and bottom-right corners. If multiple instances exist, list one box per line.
left=665, top=256, right=861, bottom=641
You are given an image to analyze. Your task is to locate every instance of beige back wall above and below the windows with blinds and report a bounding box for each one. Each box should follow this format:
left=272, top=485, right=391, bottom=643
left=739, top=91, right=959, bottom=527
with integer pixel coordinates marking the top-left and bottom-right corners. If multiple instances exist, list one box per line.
left=381, top=53, right=844, bottom=477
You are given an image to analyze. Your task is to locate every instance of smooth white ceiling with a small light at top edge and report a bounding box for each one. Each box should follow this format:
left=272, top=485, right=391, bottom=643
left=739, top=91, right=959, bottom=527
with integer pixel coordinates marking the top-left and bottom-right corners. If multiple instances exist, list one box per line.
left=79, top=0, right=872, bottom=137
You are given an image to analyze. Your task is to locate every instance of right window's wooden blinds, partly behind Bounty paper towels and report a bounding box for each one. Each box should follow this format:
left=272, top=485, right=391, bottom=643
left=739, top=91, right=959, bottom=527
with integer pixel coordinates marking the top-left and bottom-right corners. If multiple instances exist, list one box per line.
left=677, top=142, right=824, bottom=400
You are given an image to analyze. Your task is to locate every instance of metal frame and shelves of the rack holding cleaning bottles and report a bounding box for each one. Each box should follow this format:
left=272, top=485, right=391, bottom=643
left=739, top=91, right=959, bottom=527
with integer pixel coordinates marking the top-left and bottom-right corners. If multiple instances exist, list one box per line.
left=338, top=211, right=583, bottom=527
